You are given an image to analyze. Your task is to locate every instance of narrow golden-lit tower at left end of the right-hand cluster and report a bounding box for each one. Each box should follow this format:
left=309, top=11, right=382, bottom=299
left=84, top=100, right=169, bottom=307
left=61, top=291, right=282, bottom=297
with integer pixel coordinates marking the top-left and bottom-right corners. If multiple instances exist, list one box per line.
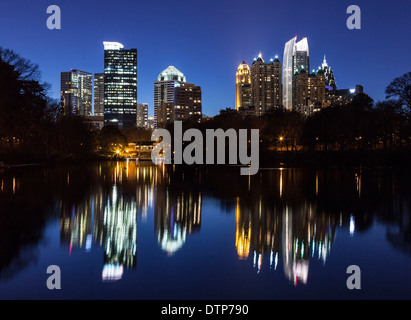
left=235, top=61, right=252, bottom=111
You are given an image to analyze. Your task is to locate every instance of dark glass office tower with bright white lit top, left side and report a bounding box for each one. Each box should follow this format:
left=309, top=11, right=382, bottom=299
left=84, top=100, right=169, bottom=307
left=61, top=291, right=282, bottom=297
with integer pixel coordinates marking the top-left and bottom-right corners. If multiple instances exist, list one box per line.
left=104, top=42, right=137, bottom=128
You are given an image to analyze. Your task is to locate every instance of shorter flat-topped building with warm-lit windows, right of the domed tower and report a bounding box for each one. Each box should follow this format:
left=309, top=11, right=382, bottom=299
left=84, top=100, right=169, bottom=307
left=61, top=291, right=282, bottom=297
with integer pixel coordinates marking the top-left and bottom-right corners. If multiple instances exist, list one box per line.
left=174, top=83, right=203, bottom=121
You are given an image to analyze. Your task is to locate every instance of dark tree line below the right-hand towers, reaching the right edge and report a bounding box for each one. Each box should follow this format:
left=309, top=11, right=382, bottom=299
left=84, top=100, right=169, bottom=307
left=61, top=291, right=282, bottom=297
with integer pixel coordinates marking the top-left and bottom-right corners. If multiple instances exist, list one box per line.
left=172, top=72, right=411, bottom=151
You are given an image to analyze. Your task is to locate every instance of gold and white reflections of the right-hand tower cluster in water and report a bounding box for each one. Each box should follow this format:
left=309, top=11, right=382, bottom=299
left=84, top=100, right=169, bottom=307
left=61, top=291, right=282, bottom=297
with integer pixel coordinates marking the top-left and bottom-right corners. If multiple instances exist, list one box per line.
left=235, top=170, right=338, bottom=285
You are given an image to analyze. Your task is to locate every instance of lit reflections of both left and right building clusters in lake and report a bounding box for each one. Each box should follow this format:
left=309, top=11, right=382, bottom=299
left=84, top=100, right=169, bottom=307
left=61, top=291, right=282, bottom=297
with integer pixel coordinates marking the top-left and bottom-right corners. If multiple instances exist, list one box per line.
left=57, top=161, right=411, bottom=285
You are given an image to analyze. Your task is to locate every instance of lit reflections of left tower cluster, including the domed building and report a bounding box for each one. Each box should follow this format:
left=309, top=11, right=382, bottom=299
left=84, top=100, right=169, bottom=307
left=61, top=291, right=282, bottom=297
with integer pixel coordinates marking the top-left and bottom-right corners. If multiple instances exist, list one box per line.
left=60, top=161, right=202, bottom=281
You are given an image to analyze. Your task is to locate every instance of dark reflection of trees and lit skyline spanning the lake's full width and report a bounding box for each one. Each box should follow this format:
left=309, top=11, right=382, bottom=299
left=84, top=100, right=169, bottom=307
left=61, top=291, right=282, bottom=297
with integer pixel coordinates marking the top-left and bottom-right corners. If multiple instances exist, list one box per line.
left=0, top=161, right=411, bottom=292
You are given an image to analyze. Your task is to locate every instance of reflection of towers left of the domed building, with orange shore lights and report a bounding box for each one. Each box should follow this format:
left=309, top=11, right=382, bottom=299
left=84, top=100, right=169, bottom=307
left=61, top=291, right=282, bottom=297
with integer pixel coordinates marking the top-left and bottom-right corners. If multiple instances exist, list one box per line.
left=60, top=161, right=159, bottom=281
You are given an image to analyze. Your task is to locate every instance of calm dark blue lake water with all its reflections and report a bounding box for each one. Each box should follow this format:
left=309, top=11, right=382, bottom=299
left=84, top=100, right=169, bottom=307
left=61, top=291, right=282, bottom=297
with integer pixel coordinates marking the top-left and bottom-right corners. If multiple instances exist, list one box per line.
left=0, top=162, right=411, bottom=300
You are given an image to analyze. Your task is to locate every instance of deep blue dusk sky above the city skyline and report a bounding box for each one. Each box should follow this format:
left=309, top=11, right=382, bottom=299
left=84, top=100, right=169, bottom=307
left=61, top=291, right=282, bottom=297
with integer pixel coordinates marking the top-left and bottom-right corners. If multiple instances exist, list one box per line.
left=0, top=0, right=411, bottom=116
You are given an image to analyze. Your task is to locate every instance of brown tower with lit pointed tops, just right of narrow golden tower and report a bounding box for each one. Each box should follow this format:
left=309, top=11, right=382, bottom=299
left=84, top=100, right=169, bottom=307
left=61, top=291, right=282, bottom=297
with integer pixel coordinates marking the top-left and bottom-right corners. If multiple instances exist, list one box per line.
left=251, top=53, right=282, bottom=116
